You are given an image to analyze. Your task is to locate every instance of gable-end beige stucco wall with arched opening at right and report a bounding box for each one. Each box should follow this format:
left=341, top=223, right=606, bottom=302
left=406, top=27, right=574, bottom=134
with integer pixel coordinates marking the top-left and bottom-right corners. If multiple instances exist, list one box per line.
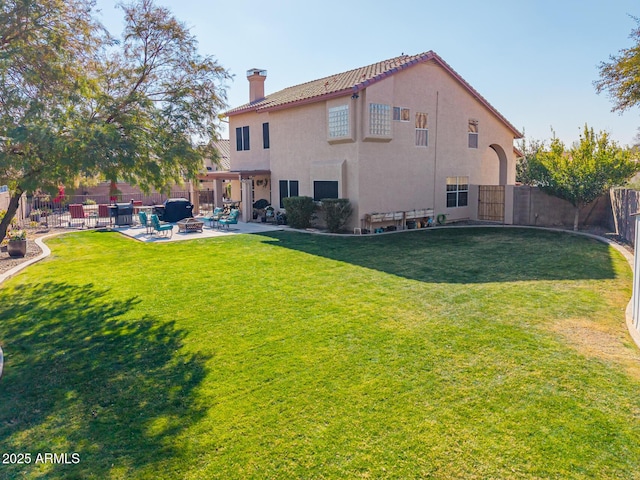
left=359, top=64, right=515, bottom=227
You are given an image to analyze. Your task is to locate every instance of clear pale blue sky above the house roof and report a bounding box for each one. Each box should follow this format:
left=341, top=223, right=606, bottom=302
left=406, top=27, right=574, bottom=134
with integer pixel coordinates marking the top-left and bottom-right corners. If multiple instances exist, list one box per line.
left=92, top=0, right=640, bottom=144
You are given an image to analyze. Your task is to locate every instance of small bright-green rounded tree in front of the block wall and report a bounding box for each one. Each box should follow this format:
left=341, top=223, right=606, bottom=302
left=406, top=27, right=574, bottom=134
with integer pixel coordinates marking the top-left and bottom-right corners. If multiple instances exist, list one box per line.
left=529, top=125, right=640, bottom=230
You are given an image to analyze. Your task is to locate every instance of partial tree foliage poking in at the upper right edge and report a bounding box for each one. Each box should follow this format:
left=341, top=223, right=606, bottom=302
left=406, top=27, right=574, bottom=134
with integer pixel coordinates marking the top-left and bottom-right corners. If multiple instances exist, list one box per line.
left=594, top=17, right=640, bottom=112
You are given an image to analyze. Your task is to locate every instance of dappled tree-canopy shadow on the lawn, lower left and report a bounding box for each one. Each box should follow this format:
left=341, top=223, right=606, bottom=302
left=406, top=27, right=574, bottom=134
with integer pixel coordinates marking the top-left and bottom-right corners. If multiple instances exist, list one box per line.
left=0, top=282, right=206, bottom=478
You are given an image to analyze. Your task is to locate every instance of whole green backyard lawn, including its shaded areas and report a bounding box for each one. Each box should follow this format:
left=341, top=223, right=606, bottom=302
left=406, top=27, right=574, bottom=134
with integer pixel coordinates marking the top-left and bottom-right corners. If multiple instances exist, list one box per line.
left=0, top=229, right=640, bottom=479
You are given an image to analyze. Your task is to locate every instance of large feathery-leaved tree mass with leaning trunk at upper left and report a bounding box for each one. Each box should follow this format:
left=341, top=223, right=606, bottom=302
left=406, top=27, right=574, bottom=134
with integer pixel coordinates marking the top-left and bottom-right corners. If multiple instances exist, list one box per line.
left=0, top=0, right=229, bottom=238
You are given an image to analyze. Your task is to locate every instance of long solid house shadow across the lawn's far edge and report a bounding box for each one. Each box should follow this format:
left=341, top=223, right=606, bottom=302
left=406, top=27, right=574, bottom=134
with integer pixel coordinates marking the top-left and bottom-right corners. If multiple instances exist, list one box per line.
left=261, top=228, right=615, bottom=284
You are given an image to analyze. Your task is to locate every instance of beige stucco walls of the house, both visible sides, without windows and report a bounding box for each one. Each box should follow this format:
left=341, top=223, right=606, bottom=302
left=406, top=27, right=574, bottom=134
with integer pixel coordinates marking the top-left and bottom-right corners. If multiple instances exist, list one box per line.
left=230, top=58, right=515, bottom=231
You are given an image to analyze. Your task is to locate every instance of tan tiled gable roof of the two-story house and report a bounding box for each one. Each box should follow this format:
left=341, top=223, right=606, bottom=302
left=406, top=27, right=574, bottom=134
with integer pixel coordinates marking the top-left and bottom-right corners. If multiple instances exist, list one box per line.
left=226, top=50, right=522, bottom=138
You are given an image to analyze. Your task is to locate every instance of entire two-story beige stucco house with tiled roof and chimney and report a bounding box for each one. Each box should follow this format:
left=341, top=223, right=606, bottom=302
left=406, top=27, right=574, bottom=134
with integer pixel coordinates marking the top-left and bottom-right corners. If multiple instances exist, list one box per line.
left=214, top=51, right=522, bottom=232
